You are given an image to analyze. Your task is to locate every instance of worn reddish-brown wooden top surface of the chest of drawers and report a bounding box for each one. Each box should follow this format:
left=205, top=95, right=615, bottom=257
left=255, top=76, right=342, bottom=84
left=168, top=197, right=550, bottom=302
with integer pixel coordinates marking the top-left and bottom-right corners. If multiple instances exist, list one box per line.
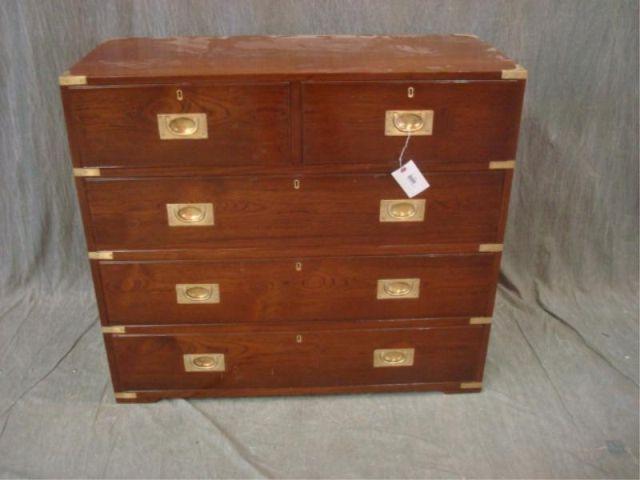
left=65, top=35, right=516, bottom=84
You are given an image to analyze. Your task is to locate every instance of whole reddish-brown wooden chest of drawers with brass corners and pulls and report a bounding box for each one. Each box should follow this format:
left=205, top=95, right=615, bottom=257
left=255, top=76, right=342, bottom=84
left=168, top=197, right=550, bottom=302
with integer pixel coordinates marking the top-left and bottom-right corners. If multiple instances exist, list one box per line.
left=60, top=35, right=526, bottom=402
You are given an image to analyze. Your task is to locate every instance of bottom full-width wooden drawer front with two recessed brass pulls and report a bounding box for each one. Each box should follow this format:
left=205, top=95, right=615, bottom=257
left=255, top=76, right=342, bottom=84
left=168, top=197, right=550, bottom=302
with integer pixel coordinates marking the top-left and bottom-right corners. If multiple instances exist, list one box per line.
left=107, top=325, right=488, bottom=391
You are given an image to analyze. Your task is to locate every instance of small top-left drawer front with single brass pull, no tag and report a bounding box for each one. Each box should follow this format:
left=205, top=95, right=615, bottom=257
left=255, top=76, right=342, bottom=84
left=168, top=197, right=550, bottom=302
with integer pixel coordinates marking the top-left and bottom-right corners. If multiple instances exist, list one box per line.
left=65, top=84, right=291, bottom=167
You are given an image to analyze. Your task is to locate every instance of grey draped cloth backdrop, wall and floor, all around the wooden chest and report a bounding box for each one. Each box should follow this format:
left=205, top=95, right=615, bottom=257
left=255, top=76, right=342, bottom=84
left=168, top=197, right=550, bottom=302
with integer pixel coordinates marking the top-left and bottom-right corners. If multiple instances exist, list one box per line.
left=0, top=0, right=638, bottom=478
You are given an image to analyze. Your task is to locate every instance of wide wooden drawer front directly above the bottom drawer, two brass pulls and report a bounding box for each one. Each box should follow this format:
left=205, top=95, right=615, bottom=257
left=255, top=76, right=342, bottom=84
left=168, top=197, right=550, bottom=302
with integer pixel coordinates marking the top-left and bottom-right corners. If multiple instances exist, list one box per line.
left=99, top=253, right=500, bottom=325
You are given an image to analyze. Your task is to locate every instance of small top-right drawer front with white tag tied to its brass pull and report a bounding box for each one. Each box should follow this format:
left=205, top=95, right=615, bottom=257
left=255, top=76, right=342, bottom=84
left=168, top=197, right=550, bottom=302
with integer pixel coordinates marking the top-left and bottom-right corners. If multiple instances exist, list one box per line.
left=303, top=81, right=524, bottom=167
